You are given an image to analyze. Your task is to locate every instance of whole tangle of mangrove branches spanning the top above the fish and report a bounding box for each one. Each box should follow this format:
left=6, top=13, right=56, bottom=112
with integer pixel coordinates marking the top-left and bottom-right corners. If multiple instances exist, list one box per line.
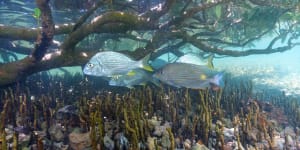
left=0, top=0, right=300, bottom=86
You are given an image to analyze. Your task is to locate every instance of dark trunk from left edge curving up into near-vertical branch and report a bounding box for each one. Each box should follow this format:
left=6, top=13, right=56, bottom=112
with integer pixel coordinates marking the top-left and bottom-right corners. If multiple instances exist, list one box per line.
left=0, top=0, right=54, bottom=85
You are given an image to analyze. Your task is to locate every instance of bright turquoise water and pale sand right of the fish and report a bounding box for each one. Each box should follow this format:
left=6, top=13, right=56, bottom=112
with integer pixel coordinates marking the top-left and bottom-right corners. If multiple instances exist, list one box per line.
left=214, top=43, right=300, bottom=97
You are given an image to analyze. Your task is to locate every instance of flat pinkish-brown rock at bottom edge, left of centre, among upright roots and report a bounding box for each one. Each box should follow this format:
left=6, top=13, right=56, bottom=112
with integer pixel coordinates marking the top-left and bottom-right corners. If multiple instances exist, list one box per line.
left=69, top=132, right=91, bottom=150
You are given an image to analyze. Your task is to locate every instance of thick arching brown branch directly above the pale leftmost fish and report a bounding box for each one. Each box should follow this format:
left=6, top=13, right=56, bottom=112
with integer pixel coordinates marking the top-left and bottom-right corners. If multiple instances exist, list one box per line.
left=62, top=11, right=156, bottom=52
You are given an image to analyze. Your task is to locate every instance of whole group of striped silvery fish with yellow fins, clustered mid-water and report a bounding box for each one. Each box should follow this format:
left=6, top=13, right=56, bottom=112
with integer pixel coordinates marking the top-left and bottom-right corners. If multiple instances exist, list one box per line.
left=83, top=51, right=224, bottom=90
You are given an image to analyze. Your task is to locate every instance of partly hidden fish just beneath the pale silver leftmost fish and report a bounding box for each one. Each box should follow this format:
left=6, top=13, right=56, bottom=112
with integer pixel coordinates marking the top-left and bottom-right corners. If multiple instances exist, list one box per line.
left=109, top=69, right=158, bottom=88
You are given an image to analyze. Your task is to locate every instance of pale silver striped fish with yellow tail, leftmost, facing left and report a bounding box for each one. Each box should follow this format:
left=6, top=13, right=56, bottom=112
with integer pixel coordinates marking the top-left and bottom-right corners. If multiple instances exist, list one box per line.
left=83, top=51, right=153, bottom=77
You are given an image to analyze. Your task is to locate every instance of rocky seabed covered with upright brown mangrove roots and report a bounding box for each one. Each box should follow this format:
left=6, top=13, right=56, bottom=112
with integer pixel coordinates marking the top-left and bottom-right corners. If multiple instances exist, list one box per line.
left=0, top=74, right=300, bottom=150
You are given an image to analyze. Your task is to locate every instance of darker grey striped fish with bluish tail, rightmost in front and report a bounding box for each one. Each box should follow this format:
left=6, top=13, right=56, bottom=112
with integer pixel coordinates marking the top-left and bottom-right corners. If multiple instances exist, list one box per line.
left=153, top=63, right=224, bottom=90
